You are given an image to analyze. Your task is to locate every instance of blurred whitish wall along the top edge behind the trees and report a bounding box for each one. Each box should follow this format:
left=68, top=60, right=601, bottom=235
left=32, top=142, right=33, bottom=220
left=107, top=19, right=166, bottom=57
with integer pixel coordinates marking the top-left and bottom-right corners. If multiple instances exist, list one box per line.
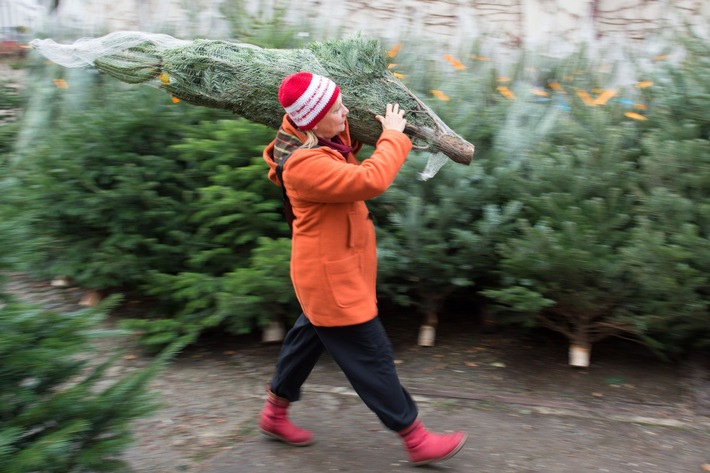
left=0, top=0, right=710, bottom=47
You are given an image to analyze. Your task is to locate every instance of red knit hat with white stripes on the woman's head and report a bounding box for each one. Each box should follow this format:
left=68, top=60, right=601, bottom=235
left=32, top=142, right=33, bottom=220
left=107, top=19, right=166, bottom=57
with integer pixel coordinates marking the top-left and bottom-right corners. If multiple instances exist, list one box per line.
left=279, top=72, right=340, bottom=130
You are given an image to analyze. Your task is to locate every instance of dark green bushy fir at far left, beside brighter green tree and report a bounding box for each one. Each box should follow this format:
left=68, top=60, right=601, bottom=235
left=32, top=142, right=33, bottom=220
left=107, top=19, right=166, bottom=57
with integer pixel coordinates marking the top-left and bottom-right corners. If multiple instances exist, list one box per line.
left=3, top=71, right=235, bottom=288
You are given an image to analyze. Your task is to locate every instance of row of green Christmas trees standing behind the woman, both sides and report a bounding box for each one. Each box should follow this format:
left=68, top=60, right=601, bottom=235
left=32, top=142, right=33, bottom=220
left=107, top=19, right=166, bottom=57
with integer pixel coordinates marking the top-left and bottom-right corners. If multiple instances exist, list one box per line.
left=1, top=27, right=710, bottom=366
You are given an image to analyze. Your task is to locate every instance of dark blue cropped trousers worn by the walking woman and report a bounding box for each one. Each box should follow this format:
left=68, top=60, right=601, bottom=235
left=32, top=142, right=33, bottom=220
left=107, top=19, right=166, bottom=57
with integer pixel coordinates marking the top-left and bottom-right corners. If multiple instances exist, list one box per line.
left=271, top=314, right=418, bottom=432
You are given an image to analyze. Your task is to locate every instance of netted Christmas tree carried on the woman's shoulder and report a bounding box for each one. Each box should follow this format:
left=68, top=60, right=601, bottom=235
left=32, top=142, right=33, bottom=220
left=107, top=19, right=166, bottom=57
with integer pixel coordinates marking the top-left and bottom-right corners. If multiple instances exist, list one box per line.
left=31, top=31, right=474, bottom=179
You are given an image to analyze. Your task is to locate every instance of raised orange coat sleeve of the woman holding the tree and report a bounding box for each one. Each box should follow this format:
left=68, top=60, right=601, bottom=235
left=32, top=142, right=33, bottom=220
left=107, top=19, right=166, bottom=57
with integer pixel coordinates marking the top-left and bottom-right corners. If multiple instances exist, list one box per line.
left=284, top=130, right=412, bottom=203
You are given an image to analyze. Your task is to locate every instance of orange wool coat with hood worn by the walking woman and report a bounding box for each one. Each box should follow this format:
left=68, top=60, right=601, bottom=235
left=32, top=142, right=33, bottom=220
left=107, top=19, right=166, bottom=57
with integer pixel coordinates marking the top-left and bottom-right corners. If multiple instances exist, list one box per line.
left=263, top=116, right=412, bottom=327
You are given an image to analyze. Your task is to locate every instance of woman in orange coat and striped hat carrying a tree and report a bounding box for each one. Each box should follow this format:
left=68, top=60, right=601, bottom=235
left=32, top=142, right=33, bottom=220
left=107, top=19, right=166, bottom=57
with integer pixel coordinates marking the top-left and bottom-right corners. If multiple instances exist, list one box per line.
left=259, top=72, right=466, bottom=465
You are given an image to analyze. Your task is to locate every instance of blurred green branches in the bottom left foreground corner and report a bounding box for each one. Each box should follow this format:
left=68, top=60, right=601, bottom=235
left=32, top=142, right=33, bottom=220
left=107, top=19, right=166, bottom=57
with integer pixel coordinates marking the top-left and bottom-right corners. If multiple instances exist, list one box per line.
left=0, top=295, right=174, bottom=473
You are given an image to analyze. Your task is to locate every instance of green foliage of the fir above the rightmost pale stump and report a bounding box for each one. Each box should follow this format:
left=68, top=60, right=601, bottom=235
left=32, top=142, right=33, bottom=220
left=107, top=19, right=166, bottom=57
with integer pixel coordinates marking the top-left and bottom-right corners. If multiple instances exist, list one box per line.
left=484, top=77, right=652, bottom=345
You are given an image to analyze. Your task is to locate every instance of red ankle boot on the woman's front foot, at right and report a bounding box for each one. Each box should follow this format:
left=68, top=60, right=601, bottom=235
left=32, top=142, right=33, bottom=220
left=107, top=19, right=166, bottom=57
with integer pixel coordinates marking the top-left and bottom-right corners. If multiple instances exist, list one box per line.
left=399, top=420, right=466, bottom=466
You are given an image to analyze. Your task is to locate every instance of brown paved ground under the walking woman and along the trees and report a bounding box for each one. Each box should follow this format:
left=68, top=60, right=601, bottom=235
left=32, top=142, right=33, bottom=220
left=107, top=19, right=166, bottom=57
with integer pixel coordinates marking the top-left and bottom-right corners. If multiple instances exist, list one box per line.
left=1, top=272, right=710, bottom=473
